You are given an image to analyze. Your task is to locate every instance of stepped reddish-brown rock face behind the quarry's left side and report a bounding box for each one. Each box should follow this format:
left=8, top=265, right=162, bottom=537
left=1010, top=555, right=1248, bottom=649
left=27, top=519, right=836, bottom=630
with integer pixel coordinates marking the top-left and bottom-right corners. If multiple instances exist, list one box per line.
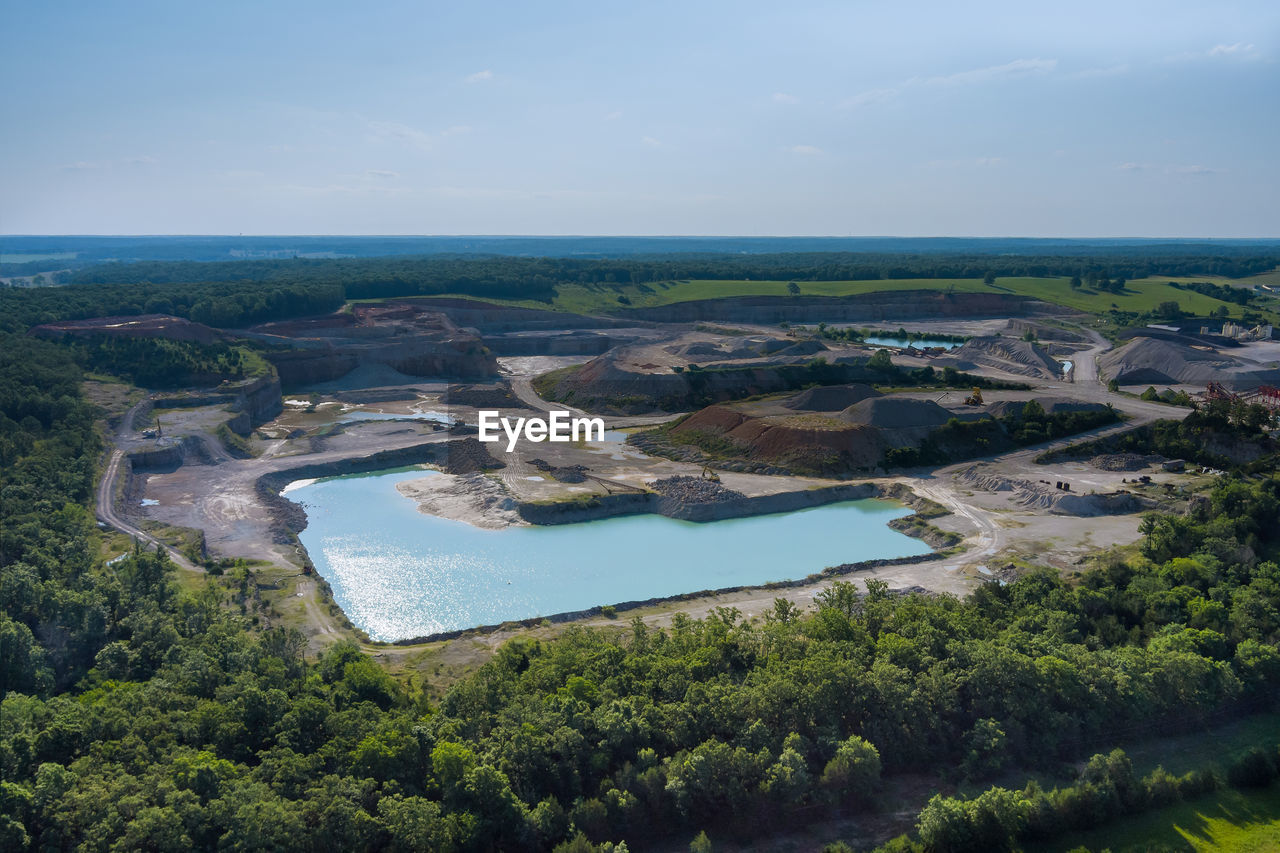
left=248, top=305, right=498, bottom=388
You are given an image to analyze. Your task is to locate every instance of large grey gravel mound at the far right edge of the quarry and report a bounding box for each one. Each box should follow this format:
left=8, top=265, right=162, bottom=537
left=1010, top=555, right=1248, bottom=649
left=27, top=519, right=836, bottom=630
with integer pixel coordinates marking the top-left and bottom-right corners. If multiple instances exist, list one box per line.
left=1098, top=337, right=1280, bottom=388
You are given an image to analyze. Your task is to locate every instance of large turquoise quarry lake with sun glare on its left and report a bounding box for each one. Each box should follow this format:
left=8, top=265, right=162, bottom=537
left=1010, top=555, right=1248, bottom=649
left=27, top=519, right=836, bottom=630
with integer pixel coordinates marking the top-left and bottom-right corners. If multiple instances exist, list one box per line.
left=287, top=469, right=929, bottom=640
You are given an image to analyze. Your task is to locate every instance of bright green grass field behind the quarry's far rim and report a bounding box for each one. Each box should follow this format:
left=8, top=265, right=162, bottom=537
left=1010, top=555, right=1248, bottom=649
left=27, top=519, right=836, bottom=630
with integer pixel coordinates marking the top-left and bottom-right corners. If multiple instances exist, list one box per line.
left=401, top=277, right=1280, bottom=321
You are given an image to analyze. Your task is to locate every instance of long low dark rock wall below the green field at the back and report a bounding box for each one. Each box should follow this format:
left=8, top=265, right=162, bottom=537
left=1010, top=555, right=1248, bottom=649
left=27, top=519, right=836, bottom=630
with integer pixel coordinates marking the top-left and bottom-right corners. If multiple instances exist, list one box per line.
left=625, top=291, right=1064, bottom=324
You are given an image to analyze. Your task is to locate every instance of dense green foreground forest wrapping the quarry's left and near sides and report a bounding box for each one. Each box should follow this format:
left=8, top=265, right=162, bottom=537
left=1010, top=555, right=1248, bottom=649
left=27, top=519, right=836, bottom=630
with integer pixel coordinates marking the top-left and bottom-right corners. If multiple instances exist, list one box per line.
left=0, top=330, right=1280, bottom=850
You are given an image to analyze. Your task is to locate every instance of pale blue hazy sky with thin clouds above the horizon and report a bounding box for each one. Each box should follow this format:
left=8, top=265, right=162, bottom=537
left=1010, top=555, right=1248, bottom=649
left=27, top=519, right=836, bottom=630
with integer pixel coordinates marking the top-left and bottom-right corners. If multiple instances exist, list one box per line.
left=0, top=0, right=1280, bottom=237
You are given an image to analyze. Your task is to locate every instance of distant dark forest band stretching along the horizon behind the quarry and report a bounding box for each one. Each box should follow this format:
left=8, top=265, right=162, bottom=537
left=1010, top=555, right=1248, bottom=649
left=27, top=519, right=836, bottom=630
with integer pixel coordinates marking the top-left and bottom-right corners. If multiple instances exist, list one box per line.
left=0, top=247, right=1280, bottom=330
